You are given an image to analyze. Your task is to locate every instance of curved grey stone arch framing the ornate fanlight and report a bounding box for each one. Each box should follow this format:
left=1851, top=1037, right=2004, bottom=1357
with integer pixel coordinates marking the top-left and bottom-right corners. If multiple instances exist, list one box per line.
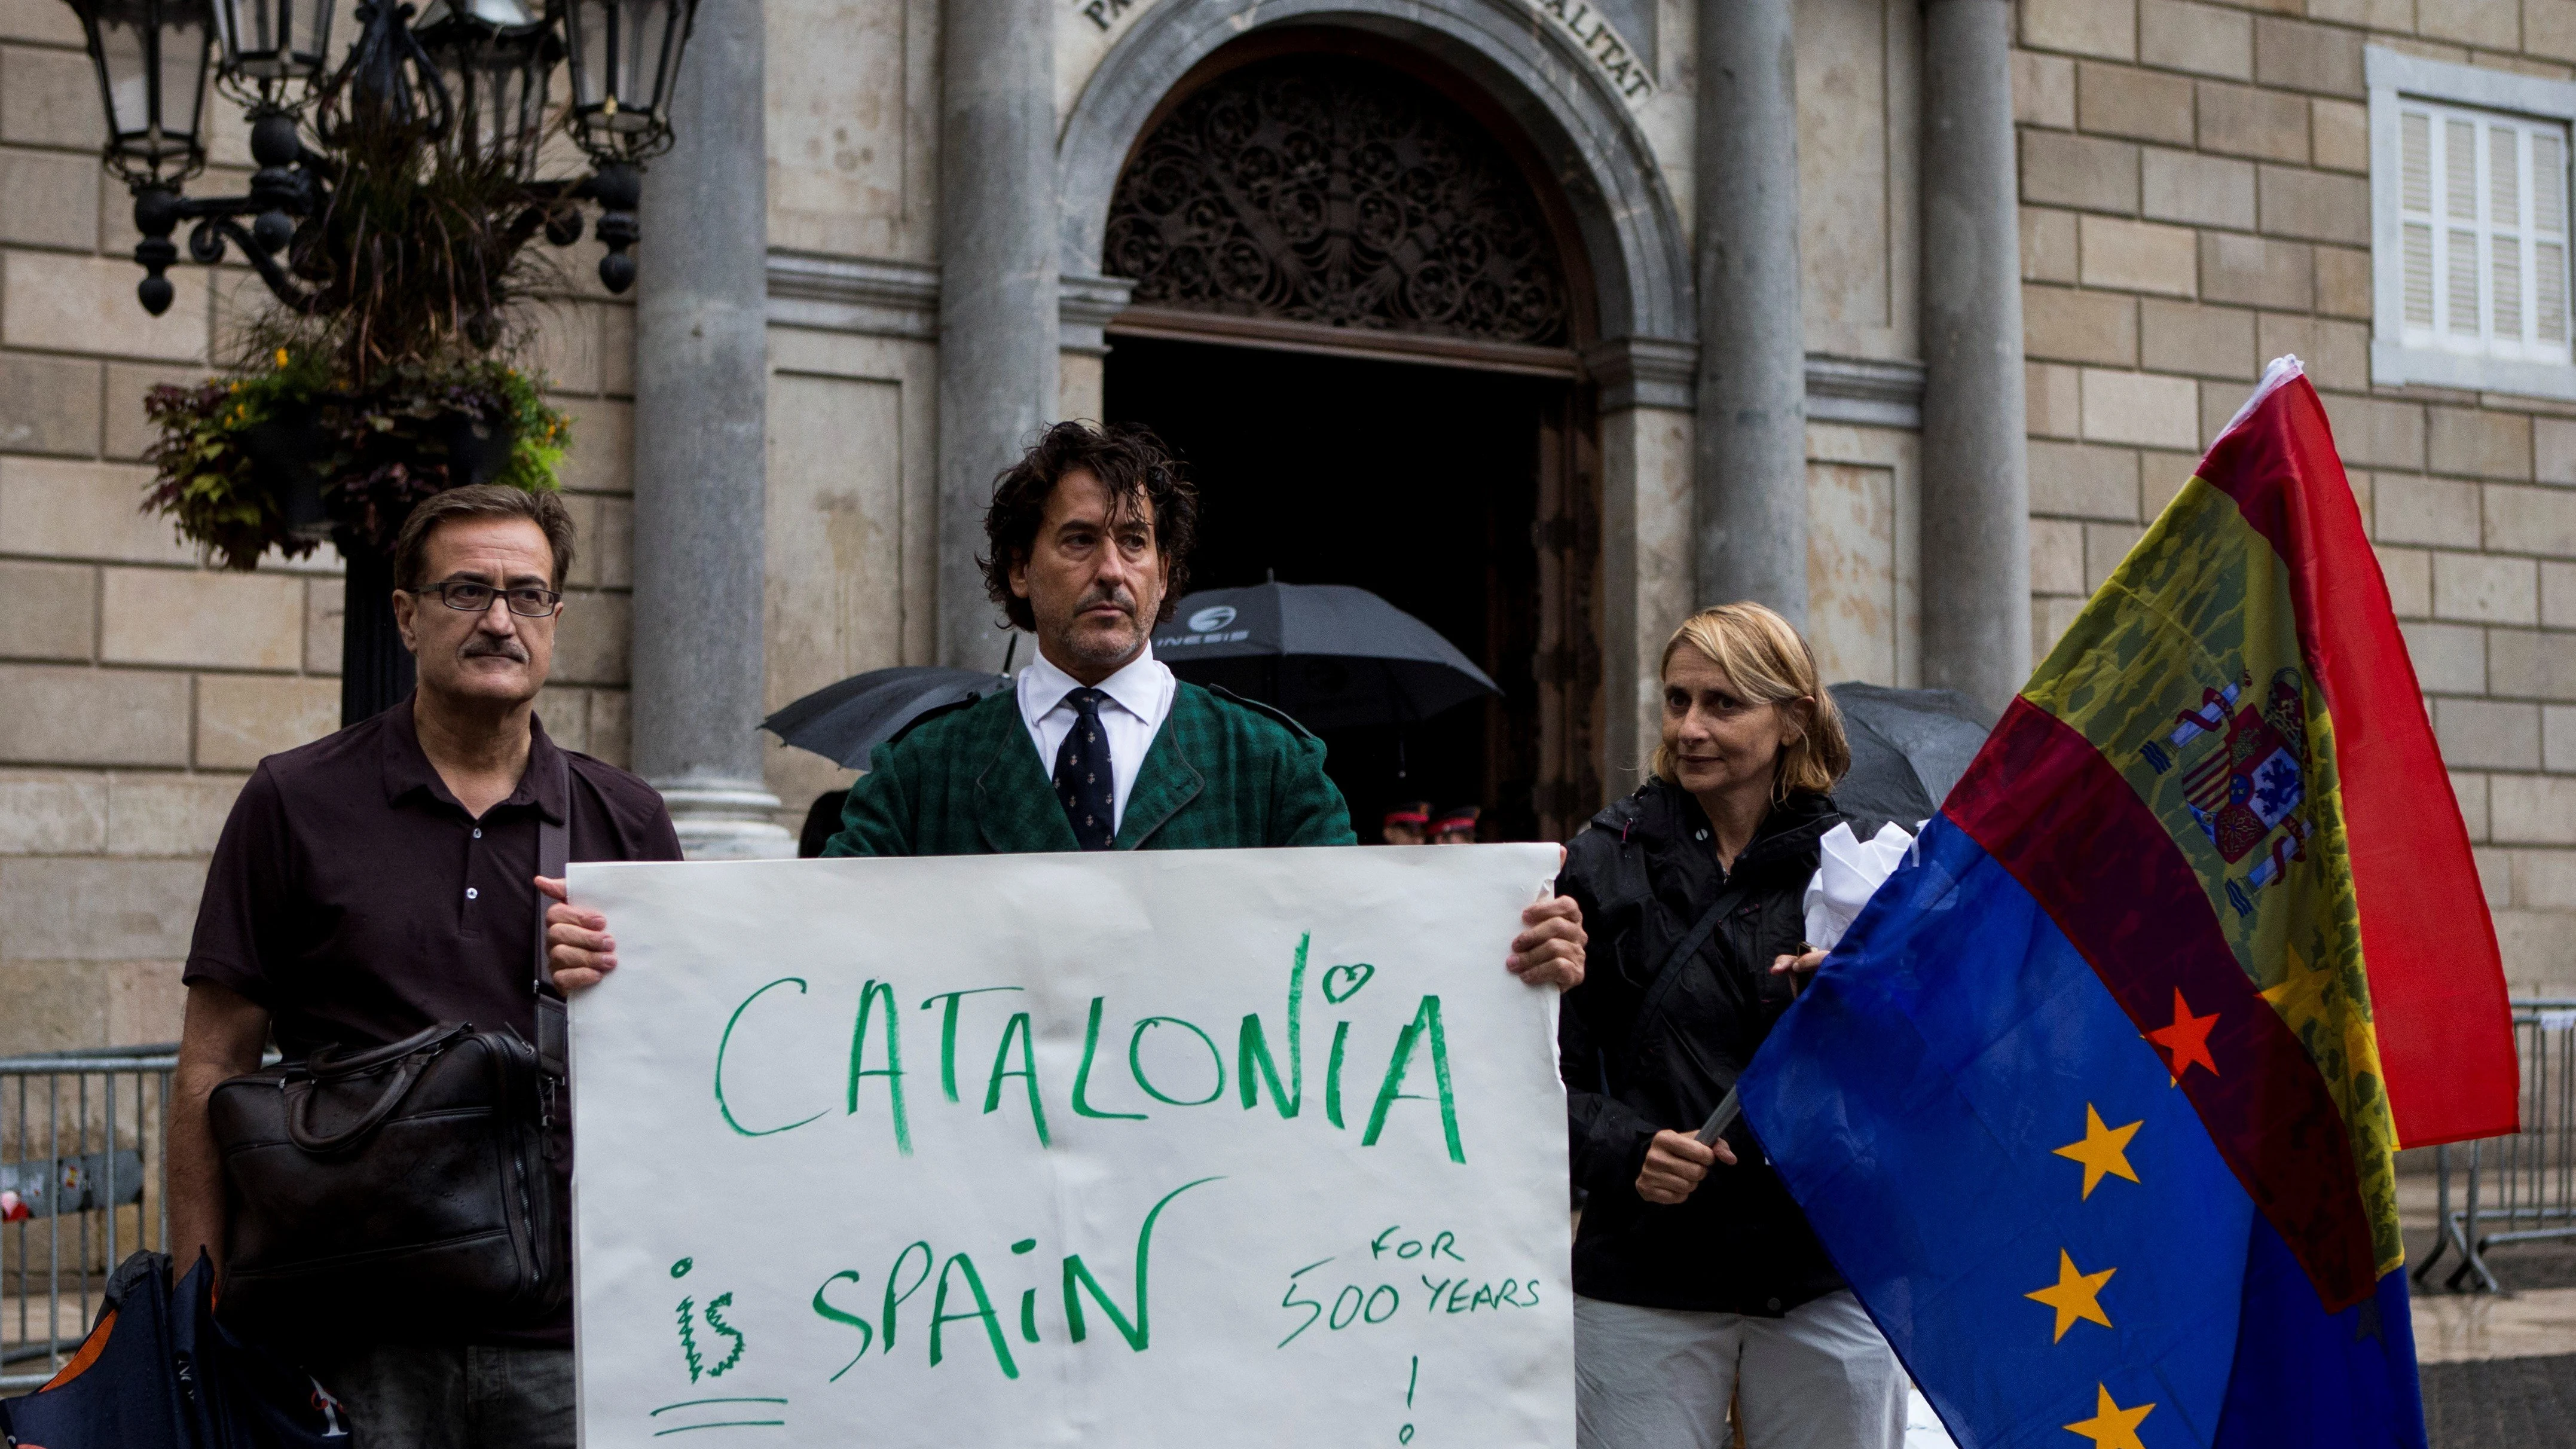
left=1056, top=0, right=1698, bottom=345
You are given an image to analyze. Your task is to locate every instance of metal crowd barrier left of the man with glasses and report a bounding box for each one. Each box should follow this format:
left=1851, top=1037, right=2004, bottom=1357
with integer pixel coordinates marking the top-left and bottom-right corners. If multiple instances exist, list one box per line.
left=0, top=1045, right=178, bottom=1395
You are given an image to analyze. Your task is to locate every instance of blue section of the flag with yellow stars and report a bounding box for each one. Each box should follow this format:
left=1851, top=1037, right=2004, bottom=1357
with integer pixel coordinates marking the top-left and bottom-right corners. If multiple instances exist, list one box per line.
left=1741, top=818, right=2424, bottom=1449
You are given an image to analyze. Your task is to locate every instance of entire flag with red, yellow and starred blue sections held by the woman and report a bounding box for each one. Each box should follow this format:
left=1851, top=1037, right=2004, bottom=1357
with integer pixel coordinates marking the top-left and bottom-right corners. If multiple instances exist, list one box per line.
left=1721, top=357, right=2517, bottom=1449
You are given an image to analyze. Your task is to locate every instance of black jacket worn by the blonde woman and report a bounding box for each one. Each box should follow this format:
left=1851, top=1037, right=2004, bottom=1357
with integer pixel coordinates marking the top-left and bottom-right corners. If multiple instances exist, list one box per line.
left=1556, top=780, right=1842, bottom=1315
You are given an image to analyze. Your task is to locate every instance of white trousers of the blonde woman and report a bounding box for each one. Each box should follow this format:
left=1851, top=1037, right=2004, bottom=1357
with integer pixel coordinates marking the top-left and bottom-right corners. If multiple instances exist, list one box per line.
left=1574, top=1289, right=1911, bottom=1449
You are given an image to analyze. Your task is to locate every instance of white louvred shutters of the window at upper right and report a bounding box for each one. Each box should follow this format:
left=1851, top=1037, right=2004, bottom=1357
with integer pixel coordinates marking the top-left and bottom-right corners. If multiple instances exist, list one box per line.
left=2395, top=98, right=2571, bottom=365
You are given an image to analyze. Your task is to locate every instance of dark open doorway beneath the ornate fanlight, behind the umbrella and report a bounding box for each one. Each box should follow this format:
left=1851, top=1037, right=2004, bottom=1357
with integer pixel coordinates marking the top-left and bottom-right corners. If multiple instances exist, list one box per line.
left=1105, top=337, right=1571, bottom=842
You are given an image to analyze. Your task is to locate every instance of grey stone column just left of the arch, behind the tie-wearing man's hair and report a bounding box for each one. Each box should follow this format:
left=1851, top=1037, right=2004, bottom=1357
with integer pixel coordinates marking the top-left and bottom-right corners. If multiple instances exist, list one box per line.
left=937, top=0, right=1059, bottom=669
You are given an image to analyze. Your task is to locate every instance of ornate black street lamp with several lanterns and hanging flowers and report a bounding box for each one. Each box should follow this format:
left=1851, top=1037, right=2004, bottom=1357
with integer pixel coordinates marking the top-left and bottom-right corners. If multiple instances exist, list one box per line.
left=65, top=0, right=698, bottom=723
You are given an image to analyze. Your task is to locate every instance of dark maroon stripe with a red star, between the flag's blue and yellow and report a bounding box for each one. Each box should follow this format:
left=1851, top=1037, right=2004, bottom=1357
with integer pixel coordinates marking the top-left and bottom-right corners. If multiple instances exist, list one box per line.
left=1942, top=700, right=2378, bottom=1313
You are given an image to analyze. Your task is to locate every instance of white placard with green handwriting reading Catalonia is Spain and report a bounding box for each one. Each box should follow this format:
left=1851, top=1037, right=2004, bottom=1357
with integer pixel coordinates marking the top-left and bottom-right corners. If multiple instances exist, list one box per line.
left=572, top=844, right=1574, bottom=1449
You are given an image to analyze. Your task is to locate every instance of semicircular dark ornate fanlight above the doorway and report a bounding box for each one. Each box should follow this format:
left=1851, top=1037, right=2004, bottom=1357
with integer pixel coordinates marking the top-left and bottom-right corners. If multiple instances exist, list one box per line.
left=1102, top=57, right=1566, bottom=347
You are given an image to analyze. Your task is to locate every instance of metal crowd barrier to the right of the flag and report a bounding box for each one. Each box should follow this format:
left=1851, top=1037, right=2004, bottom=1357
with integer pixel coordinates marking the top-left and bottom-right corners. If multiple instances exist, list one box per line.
left=2414, top=999, right=2576, bottom=1292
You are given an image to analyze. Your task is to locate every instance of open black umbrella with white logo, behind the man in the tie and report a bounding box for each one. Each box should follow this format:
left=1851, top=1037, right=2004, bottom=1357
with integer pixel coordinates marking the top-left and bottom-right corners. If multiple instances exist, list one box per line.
left=1154, top=582, right=1502, bottom=728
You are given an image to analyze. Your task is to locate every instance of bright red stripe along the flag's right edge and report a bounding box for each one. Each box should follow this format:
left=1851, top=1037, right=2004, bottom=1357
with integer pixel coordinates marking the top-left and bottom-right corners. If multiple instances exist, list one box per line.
left=2200, top=378, right=2519, bottom=1148
